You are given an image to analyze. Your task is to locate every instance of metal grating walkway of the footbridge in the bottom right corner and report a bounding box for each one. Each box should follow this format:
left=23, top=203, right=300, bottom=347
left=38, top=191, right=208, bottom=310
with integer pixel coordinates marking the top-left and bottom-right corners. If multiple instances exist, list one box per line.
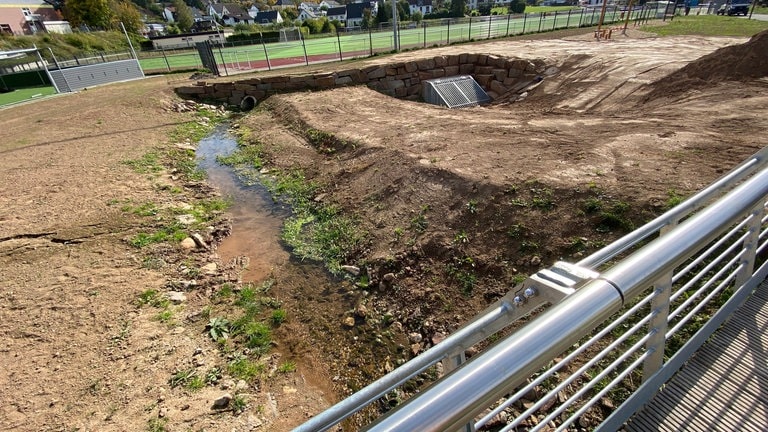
left=626, top=282, right=768, bottom=432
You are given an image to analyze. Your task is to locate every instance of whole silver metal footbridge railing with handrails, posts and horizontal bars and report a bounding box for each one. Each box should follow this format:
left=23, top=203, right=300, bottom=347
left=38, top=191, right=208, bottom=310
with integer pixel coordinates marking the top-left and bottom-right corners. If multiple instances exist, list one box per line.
left=295, top=148, right=768, bottom=432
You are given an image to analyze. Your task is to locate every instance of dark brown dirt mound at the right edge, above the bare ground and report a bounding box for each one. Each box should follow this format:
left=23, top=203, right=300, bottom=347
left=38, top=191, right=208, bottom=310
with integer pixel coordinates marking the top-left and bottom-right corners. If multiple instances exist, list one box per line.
left=643, top=30, right=768, bottom=102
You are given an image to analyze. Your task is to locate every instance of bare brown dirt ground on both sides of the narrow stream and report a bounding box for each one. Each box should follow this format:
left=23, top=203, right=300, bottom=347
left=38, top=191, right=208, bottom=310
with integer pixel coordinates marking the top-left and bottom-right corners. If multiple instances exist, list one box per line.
left=0, top=28, right=768, bottom=431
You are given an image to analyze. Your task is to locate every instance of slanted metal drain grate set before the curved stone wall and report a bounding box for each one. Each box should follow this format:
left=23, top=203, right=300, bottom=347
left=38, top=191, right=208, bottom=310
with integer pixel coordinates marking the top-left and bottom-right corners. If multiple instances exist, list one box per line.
left=424, top=75, right=491, bottom=108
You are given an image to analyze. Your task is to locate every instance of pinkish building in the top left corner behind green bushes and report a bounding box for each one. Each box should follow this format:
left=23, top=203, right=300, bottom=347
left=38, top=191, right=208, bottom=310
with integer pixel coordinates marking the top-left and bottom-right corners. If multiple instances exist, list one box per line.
left=0, top=0, right=61, bottom=35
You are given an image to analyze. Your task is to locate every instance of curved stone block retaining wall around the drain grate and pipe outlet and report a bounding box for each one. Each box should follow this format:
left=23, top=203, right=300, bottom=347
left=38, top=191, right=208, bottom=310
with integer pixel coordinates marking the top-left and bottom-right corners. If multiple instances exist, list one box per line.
left=176, top=54, right=546, bottom=109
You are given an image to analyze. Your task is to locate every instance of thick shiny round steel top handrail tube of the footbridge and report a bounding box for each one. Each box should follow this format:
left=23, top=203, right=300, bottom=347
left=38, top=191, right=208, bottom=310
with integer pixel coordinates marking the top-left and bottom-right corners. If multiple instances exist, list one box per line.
left=366, top=161, right=768, bottom=431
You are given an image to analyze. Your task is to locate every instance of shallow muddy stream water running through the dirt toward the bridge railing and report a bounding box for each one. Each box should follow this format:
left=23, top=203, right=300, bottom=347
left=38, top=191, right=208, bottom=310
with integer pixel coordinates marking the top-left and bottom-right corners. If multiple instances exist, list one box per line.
left=196, top=125, right=354, bottom=412
